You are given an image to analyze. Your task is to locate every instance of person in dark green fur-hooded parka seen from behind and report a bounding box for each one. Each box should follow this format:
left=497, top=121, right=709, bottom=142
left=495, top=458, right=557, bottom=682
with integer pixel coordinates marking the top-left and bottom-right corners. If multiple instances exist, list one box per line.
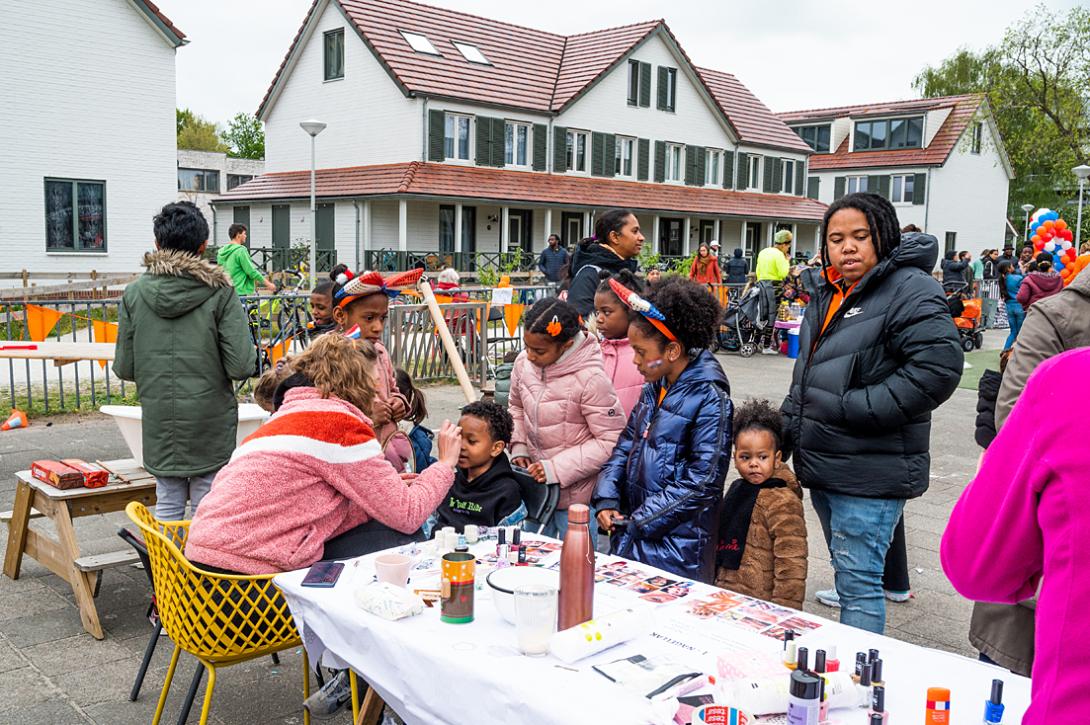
left=113, top=202, right=257, bottom=521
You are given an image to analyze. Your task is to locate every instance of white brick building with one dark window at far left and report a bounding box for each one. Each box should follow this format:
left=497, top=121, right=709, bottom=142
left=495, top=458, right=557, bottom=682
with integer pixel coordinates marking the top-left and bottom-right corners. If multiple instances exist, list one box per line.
left=0, top=0, right=186, bottom=273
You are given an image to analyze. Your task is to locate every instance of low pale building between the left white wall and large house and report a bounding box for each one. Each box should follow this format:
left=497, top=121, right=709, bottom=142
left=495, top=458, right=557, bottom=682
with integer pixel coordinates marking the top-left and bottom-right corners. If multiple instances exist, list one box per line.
left=178, top=148, right=265, bottom=244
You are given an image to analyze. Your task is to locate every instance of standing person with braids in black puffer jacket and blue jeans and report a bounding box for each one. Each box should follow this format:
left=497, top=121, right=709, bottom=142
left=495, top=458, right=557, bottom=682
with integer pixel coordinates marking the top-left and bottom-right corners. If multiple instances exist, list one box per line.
left=782, top=193, right=965, bottom=633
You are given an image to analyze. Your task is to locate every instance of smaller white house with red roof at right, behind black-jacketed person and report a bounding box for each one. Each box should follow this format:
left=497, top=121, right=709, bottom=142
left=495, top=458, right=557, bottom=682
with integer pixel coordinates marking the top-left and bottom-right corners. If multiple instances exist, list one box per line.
left=778, top=95, right=1014, bottom=256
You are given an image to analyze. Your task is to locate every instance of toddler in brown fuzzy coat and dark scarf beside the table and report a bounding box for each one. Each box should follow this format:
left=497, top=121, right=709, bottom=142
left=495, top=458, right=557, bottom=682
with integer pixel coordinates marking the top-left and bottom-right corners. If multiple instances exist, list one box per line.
left=715, top=400, right=807, bottom=609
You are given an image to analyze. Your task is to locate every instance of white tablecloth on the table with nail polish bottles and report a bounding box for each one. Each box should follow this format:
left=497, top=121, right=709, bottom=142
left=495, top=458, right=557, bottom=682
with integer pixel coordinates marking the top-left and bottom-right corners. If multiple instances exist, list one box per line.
left=275, top=542, right=1029, bottom=725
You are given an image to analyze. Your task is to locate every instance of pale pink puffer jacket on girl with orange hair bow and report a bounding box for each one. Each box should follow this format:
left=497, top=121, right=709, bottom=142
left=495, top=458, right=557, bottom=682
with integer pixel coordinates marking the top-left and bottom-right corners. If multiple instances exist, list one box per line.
left=509, top=333, right=625, bottom=509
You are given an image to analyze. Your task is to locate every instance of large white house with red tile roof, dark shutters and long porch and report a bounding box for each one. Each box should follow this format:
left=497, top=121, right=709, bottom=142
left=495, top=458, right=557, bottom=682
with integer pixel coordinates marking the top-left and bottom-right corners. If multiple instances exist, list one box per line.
left=215, top=0, right=824, bottom=272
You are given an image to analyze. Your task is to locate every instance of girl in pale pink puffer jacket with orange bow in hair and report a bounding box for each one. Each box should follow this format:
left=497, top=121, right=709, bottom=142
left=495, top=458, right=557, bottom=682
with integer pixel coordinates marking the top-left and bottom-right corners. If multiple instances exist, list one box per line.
left=509, top=298, right=625, bottom=539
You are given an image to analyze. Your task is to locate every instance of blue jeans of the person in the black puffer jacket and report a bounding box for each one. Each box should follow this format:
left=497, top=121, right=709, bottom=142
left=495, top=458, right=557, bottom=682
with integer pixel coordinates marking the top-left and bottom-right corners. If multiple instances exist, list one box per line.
left=810, top=488, right=905, bottom=635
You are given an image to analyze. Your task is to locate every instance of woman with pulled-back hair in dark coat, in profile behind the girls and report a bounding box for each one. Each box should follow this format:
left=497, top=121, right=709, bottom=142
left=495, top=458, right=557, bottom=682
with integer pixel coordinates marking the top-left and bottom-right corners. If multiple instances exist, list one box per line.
left=567, top=209, right=643, bottom=319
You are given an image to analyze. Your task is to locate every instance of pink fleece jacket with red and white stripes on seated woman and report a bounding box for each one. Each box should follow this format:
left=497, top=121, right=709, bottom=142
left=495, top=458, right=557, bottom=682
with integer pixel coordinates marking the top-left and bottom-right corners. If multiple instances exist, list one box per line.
left=185, top=387, right=455, bottom=573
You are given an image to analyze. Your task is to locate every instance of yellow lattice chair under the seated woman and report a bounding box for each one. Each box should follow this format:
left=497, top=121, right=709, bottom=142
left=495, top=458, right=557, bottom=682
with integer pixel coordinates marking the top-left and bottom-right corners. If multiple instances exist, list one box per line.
left=125, top=502, right=311, bottom=725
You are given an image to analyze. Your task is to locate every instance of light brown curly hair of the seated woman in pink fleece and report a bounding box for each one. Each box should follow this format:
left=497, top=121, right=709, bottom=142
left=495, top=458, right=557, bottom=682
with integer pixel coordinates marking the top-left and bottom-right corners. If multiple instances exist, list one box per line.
left=286, top=335, right=378, bottom=415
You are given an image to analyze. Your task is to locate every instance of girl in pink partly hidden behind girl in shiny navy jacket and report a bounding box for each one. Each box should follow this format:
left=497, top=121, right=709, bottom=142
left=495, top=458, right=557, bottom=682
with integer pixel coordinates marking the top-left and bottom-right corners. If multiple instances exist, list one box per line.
left=594, top=269, right=643, bottom=416
